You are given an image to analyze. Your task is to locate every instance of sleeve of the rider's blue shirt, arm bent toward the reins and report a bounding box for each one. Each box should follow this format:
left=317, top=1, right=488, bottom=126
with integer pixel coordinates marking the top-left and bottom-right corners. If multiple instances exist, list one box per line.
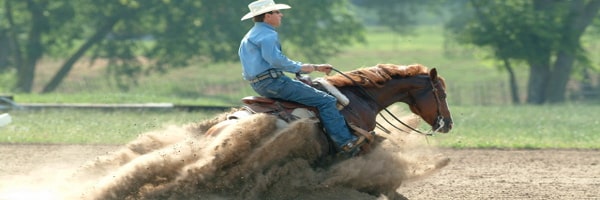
left=261, top=33, right=302, bottom=73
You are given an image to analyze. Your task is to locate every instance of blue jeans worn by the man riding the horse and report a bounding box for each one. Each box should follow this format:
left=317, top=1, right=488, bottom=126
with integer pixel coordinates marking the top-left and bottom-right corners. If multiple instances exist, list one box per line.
left=251, top=76, right=356, bottom=147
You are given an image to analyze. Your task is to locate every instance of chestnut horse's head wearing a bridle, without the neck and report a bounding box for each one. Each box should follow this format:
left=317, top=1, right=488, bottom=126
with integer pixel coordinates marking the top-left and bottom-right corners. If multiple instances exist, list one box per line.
left=408, top=68, right=453, bottom=133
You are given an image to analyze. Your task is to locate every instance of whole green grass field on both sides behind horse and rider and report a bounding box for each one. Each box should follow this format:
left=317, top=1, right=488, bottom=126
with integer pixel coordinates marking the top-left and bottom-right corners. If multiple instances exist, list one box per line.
left=0, top=27, right=600, bottom=149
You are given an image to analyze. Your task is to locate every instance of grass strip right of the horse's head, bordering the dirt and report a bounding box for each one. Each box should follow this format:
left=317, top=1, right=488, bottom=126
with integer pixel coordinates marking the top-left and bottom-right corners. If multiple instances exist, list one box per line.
left=434, top=104, right=600, bottom=149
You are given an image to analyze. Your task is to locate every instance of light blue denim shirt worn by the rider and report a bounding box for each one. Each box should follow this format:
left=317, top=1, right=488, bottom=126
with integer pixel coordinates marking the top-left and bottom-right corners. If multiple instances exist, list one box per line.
left=238, top=22, right=302, bottom=80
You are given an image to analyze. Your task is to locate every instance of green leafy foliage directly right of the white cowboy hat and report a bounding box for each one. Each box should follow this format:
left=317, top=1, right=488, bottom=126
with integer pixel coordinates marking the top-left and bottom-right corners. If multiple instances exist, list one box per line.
left=282, top=0, right=364, bottom=63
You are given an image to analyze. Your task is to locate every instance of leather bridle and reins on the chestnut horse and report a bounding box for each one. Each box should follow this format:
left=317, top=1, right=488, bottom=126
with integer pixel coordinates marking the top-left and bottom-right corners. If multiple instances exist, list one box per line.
left=331, top=67, right=445, bottom=136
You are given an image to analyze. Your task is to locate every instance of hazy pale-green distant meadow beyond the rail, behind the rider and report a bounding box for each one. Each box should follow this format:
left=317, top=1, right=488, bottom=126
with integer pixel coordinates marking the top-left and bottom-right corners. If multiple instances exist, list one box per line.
left=6, top=26, right=600, bottom=105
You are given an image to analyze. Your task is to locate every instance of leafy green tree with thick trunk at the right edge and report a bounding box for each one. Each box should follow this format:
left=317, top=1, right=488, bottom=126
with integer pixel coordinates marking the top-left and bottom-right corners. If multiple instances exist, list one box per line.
left=447, top=0, right=600, bottom=104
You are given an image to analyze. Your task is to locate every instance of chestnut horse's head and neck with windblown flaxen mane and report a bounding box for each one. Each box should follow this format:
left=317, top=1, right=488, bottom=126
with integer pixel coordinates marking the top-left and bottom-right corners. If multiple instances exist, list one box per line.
left=327, top=64, right=452, bottom=133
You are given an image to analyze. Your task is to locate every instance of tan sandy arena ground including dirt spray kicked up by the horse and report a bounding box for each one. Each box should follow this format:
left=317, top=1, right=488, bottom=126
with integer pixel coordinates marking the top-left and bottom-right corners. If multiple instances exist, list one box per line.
left=0, top=113, right=600, bottom=200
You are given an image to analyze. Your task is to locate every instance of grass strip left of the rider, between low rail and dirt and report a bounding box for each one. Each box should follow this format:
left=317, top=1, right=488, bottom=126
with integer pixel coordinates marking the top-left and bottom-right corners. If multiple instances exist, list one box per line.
left=0, top=109, right=220, bottom=144
